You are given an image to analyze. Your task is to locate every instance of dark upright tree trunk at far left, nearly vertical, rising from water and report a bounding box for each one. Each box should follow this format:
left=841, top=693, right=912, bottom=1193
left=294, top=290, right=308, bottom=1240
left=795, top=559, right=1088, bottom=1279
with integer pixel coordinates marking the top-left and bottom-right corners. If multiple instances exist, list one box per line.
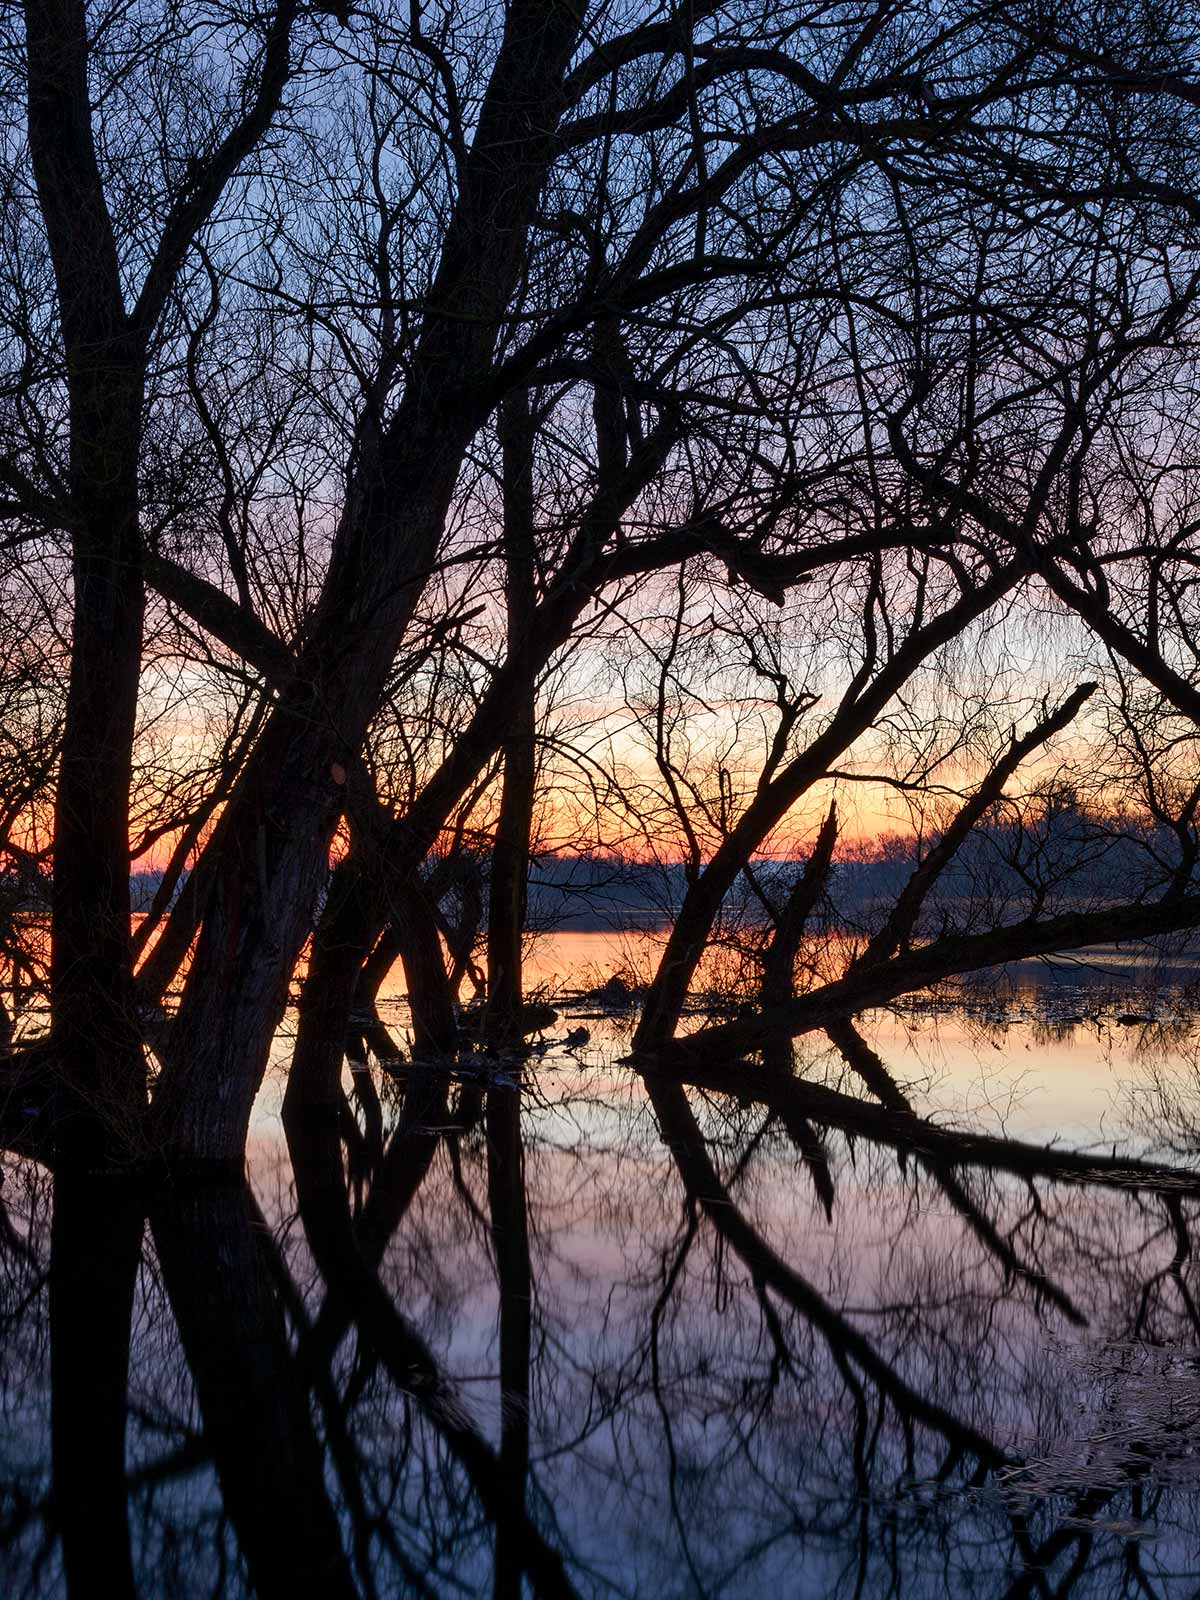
left=26, top=0, right=144, bottom=1160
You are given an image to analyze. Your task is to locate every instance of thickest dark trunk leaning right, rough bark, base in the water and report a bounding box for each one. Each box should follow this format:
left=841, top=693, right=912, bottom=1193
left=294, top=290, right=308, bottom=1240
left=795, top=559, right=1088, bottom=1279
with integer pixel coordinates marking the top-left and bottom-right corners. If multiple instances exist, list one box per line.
left=154, top=0, right=581, bottom=1160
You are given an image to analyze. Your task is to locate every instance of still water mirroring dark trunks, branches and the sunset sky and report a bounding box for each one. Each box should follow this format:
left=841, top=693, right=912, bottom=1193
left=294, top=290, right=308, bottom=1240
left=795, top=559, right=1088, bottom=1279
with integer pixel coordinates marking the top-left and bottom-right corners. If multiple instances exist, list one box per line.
left=0, top=934, right=1200, bottom=1600
